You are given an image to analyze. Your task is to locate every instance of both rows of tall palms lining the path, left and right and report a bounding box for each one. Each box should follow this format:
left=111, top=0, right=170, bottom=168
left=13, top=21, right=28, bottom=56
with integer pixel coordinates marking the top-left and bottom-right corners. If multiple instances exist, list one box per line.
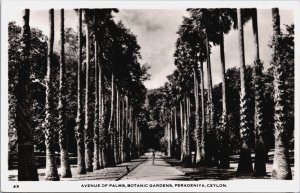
left=9, top=8, right=294, bottom=181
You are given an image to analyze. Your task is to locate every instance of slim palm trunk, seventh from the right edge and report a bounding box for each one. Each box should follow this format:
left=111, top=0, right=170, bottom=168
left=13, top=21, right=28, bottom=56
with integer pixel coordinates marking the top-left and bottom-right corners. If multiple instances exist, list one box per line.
left=193, top=63, right=201, bottom=164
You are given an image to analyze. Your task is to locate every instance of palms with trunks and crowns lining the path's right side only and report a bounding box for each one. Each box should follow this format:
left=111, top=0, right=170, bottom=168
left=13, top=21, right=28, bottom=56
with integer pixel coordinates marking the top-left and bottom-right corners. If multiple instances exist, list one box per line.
left=158, top=8, right=293, bottom=179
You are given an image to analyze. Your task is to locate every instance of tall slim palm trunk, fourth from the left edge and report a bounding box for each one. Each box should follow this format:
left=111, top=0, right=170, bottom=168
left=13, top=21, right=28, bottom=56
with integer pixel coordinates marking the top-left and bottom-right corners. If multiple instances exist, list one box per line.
left=75, top=9, right=86, bottom=174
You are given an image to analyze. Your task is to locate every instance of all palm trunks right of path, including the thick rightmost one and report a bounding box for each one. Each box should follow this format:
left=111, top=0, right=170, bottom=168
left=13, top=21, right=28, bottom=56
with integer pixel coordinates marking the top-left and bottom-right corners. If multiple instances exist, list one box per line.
left=169, top=9, right=290, bottom=178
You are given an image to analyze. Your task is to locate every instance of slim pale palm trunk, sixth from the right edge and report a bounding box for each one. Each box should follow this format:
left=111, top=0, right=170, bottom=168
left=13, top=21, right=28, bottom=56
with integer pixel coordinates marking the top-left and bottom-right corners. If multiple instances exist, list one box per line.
left=200, top=61, right=206, bottom=162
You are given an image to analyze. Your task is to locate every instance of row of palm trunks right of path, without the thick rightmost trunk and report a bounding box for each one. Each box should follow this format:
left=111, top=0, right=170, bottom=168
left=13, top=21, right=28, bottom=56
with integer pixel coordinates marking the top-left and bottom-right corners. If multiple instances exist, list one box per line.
left=170, top=9, right=265, bottom=175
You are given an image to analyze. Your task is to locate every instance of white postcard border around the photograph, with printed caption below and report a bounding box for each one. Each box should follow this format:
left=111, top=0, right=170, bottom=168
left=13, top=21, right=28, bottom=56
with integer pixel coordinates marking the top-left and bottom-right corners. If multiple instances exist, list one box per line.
left=1, top=0, right=300, bottom=192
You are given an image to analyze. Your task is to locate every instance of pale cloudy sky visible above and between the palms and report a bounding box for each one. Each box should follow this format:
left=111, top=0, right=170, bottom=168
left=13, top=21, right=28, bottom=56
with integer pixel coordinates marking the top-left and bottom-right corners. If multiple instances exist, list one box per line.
left=9, top=9, right=294, bottom=89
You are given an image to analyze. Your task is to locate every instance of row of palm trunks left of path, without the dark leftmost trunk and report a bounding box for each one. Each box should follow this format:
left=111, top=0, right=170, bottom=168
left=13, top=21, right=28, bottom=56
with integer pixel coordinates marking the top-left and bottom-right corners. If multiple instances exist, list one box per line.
left=42, top=9, right=140, bottom=180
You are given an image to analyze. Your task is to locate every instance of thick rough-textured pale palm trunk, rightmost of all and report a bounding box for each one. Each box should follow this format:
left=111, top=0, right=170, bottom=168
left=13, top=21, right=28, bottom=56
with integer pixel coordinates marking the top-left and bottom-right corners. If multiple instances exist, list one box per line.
left=272, top=8, right=292, bottom=179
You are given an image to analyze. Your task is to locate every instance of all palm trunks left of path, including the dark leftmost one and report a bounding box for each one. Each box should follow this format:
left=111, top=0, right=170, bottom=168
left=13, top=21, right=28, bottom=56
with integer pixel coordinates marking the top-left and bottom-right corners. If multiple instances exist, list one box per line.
left=16, top=9, right=141, bottom=181
